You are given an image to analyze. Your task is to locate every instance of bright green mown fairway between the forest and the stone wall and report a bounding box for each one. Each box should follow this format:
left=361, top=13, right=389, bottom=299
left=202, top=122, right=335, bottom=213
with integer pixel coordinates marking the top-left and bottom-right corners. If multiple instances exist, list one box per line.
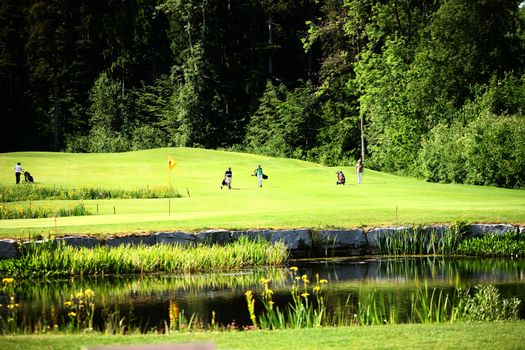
left=0, top=148, right=525, bottom=237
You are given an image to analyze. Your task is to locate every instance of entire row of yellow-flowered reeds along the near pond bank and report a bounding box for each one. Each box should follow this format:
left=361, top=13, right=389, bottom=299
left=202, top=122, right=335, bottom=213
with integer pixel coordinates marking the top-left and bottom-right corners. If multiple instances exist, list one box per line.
left=0, top=275, right=520, bottom=334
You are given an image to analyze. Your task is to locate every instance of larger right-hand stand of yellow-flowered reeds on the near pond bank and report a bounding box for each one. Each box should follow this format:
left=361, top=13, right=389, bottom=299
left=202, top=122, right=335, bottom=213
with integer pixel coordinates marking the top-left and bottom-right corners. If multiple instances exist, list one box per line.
left=246, top=270, right=521, bottom=329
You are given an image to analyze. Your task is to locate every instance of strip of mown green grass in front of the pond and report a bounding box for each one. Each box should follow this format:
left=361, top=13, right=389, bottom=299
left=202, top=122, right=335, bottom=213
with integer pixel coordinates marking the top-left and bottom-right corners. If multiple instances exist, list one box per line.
left=0, top=322, right=525, bottom=350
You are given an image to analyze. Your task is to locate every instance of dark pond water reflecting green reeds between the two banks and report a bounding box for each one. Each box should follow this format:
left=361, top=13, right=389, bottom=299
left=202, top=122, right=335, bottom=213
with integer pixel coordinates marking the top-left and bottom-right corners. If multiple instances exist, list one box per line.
left=4, top=257, right=525, bottom=330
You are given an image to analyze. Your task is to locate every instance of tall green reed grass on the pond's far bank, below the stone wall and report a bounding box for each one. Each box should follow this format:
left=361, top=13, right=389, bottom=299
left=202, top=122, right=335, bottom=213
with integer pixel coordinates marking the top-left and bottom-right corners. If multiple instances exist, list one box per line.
left=0, top=238, right=288, bottom=278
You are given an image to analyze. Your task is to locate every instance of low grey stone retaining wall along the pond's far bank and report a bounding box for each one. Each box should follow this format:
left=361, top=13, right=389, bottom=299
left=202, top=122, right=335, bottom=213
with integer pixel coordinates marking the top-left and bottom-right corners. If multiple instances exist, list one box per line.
left=0, top=224, right=525, bottom=259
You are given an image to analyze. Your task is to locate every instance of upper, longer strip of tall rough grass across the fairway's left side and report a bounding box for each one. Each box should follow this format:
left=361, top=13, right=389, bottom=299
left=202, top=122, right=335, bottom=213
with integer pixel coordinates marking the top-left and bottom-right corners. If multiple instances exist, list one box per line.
left=0, top=184, right=181, bottom=203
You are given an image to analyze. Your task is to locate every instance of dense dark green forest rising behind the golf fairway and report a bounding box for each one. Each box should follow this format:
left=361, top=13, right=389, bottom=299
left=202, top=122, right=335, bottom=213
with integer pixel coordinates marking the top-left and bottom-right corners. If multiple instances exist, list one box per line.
left=0, top=0, right=525, bottom=188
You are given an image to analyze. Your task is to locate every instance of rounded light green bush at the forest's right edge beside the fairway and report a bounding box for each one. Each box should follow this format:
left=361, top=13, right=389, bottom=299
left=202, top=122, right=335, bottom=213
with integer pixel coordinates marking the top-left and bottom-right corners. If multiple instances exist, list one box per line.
left=419, top=114, right=525, bottom=188
